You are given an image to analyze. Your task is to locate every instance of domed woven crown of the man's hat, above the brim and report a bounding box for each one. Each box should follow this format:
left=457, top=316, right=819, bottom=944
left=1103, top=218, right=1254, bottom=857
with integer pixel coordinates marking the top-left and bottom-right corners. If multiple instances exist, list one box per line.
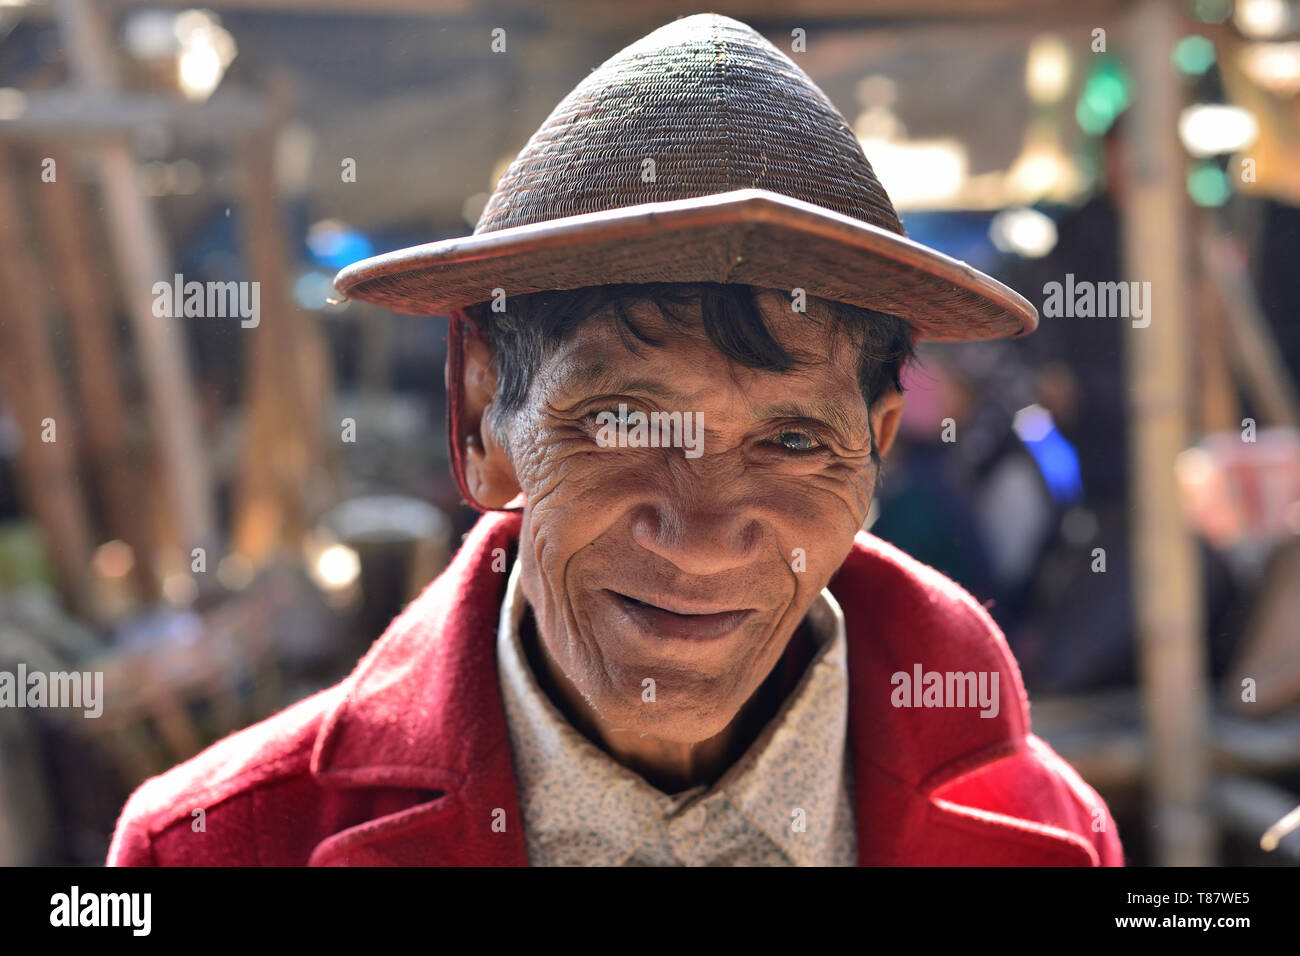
left=475, top=14, right=904, bottom=235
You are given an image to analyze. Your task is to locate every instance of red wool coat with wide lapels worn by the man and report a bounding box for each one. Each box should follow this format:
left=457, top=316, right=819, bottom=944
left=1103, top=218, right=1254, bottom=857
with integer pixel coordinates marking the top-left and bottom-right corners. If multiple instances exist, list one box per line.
left=108, top=512, right=1122, bottom=866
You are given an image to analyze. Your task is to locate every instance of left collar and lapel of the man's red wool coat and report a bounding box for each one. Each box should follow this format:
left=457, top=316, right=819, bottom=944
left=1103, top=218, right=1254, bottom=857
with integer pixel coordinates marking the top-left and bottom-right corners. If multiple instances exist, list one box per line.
left=311, top=514, right=528, bottom=866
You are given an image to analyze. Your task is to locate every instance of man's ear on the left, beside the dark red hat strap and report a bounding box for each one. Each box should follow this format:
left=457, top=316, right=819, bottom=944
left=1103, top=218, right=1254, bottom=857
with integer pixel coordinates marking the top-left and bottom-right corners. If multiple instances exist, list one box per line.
left=447, top=329, right=519, bottom=509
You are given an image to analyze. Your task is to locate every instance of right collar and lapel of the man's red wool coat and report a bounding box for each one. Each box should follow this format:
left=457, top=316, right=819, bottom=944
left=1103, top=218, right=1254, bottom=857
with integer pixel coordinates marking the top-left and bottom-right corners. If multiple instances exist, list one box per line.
left=831, top=532, right=1096, bottom=866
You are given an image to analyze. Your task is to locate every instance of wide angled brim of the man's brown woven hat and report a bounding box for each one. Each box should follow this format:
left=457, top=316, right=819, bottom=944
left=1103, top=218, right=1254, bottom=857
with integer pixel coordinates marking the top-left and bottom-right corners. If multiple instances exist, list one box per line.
left=334, top=189, right=1039, bottom=342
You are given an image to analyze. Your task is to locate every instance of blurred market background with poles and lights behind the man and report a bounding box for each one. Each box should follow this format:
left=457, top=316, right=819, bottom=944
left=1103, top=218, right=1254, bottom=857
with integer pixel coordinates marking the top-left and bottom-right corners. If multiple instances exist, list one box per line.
left=0, top=0, right=1300, bottom=865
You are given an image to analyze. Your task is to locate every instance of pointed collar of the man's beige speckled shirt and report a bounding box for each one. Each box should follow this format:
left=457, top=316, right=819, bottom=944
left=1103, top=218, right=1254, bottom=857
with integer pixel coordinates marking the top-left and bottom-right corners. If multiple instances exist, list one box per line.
left=497, top=559, right=852, bottom=866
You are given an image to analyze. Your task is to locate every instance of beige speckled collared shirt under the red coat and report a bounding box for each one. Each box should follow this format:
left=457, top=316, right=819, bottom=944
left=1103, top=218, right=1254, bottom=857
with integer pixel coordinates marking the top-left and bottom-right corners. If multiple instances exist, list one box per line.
left=497, top=561, right=857, bottom=866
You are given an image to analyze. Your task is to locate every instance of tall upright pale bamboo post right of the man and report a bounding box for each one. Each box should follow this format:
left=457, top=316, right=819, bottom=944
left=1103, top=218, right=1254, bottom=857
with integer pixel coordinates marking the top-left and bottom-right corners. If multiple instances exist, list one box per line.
left=1122, top=0, right=1214, bottom=866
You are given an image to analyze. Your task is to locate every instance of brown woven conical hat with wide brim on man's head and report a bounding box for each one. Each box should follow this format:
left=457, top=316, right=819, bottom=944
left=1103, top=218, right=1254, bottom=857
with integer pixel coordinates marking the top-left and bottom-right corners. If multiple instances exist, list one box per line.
left=334, top=14, right=1037, bottom=341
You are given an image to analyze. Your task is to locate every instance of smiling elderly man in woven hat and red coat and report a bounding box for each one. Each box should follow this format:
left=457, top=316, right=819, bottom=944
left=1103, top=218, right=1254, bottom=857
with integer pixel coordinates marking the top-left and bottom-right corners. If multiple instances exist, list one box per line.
left=109, top=14, right=1122, bottom=865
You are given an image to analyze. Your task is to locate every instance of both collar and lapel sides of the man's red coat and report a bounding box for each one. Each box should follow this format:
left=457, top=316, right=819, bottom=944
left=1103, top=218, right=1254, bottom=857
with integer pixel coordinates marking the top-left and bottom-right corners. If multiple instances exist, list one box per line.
left=311, top=512, right=1089, bottom=865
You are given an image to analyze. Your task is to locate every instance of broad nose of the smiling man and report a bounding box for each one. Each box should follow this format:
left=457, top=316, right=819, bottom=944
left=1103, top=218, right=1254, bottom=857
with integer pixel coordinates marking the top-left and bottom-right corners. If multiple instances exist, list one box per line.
left=632, top=501, right=763, bottom=575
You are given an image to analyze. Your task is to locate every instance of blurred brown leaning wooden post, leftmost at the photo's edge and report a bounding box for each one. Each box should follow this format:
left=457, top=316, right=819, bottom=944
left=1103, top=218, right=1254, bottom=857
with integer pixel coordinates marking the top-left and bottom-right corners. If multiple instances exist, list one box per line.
left=0, top=150, right=94, bottom=614
